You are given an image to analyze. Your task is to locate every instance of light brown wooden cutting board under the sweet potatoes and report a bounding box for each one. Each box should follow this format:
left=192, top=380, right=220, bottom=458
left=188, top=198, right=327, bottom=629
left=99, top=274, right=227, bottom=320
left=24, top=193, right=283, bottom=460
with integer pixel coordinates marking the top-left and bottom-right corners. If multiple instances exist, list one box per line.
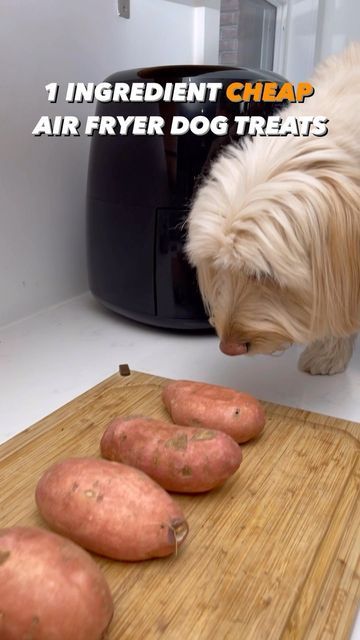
left=0, top=372, right=360, bottom=640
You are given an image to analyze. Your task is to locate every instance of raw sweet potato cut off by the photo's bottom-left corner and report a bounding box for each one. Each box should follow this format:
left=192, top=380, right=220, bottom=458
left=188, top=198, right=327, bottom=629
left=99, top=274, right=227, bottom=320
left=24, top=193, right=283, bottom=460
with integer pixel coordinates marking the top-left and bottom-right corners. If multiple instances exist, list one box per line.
left=0, top=527, right=113, bottom=640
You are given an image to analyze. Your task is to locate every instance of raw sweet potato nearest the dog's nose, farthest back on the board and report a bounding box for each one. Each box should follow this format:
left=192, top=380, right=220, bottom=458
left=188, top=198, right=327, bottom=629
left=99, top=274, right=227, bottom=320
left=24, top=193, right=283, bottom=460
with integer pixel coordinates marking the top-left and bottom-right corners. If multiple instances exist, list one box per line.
left=162, top=380, right=265, bottom=443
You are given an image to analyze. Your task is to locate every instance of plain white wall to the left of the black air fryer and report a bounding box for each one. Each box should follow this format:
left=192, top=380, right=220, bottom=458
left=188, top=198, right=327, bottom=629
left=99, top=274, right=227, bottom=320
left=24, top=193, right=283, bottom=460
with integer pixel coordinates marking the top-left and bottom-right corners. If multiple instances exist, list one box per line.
left=0, top=0, right=194, bottom=325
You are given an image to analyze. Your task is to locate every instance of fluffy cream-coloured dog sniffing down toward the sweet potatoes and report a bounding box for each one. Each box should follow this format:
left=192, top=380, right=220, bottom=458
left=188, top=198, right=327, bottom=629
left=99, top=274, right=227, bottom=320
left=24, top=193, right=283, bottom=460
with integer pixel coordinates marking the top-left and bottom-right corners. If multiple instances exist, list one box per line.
left=186, top=43, right=360, bottom=374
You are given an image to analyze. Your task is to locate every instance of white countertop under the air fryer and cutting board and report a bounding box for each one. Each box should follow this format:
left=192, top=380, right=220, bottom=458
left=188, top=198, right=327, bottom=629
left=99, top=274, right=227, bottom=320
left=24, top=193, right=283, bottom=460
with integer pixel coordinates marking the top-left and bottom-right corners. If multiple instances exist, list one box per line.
left=0, top=294, right=360, bottom=640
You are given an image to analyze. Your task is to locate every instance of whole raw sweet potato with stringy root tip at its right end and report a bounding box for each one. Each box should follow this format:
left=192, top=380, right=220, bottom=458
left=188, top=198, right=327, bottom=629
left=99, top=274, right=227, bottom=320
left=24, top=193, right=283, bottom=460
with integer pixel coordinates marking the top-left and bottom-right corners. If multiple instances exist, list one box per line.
left=35, top=458, right=188, bottom=560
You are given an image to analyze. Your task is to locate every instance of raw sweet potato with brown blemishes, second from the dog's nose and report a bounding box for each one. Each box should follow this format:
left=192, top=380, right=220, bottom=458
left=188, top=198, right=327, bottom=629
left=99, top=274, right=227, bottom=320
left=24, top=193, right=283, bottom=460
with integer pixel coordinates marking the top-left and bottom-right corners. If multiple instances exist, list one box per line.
left=100, top=416, right=242, bottom=493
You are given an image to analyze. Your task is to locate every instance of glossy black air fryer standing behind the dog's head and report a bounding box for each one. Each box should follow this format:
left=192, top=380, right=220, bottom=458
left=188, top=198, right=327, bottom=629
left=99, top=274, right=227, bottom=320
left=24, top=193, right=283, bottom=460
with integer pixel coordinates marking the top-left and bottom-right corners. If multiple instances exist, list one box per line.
left=87, top=65, right=284, bottom=329
